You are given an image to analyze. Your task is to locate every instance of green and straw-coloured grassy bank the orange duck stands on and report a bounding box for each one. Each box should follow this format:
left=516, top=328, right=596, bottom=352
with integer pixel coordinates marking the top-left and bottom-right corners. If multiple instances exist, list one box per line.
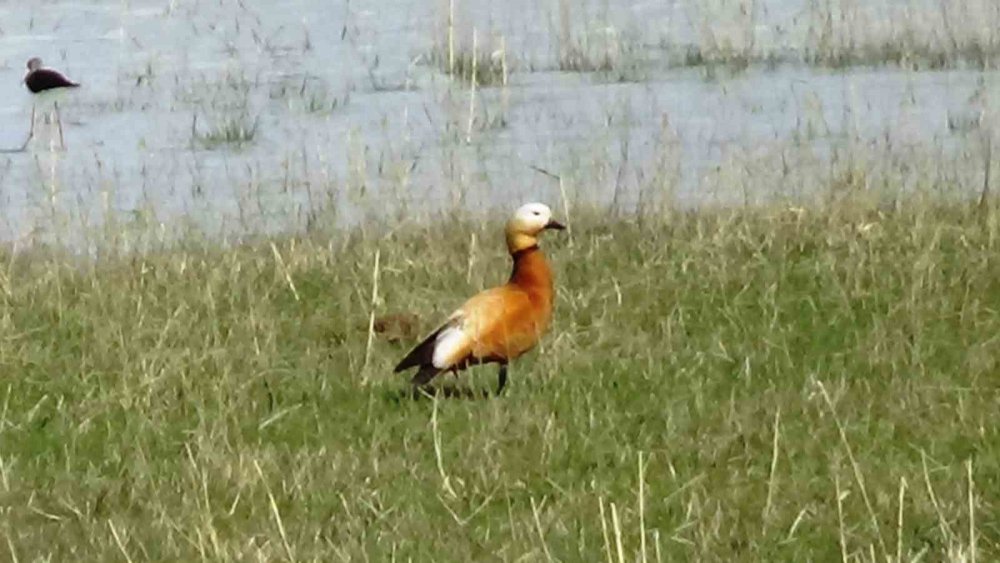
left=0, top=199, right=1000, bottom=561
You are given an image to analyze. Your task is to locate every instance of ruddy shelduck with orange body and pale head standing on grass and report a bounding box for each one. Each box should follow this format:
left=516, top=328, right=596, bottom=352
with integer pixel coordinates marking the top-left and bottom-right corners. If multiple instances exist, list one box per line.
left=395, top=203, right=566, bottom=394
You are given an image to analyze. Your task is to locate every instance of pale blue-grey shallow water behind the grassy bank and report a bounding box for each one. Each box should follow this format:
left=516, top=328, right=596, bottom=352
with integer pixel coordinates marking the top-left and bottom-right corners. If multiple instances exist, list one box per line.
left=0, top=0, right=1000, bottom=247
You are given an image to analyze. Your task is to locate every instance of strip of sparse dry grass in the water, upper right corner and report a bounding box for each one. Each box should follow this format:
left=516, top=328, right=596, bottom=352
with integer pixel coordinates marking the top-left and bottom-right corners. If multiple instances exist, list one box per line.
left=659, top=0, right=1000, bottom=72
